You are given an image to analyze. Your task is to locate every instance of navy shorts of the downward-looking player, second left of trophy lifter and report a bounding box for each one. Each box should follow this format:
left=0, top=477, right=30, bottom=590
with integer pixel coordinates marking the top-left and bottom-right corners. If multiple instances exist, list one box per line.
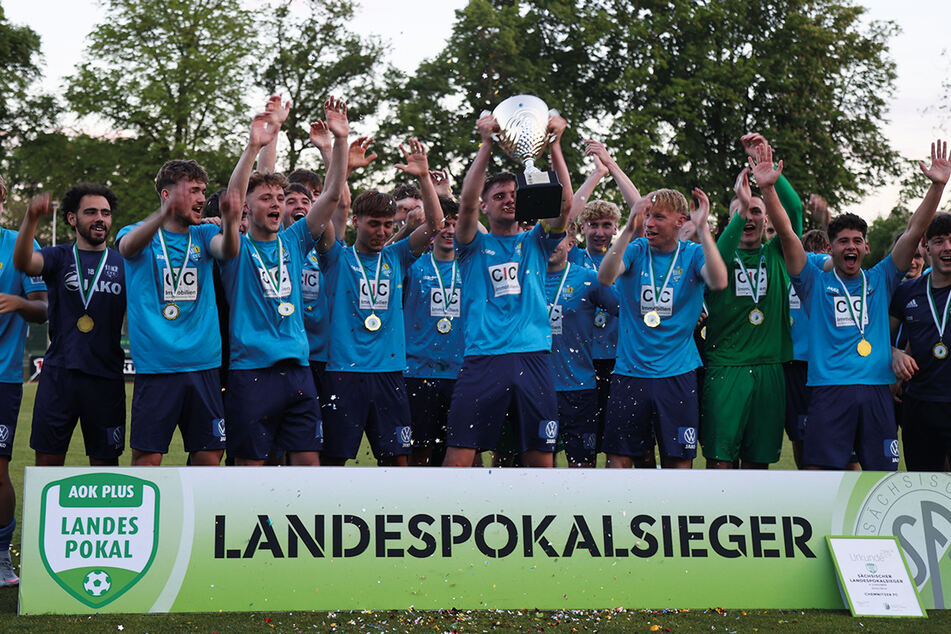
left=322, top=372, right=413, bottom=460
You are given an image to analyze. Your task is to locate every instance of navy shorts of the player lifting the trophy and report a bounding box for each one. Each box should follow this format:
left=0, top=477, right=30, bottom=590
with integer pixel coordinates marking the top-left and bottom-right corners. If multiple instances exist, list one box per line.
left=446, top=352, right=558, bottom=452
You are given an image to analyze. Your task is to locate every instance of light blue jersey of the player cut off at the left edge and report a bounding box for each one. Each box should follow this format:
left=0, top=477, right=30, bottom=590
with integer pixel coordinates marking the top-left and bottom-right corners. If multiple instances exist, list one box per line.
left=0, top=228, right=46, bottom=383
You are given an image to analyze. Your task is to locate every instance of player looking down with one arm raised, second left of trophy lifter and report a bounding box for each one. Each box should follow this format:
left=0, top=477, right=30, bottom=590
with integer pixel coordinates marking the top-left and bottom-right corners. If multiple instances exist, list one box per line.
left=320, top=139, right=442, bottom=466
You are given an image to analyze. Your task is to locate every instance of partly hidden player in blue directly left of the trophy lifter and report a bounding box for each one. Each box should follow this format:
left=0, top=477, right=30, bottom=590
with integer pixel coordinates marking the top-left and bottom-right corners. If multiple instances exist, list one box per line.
left=403, top=198, right=465, bottom=466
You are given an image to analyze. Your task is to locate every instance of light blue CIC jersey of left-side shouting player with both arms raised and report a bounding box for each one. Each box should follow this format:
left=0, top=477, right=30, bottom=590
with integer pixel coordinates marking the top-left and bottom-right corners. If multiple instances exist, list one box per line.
left=220, top=218, right=314, bottom=370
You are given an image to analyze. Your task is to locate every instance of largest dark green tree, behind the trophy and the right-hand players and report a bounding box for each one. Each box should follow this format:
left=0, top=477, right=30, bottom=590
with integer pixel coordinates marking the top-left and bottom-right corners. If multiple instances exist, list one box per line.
left=376, top=0, right=896, bottom=220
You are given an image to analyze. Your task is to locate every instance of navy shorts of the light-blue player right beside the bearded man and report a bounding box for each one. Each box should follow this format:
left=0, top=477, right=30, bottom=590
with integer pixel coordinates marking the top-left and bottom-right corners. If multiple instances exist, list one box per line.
left=129, top=368, right=225, bottom=454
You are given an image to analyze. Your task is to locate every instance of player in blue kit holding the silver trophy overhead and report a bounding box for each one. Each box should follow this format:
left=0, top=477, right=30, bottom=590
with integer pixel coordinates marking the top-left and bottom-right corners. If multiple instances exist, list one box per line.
left=443, top=108, right=572, bottom=467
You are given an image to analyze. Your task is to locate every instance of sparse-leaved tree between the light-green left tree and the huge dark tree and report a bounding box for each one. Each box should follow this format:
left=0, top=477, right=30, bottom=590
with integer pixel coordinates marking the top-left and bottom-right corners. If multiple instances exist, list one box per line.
left=260, top=0, right=385, bottom=170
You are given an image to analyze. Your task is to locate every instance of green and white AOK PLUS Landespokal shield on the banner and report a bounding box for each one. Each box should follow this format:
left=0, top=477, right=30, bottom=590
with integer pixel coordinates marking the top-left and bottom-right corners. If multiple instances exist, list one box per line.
left=40, top=473, right=159, bottom=608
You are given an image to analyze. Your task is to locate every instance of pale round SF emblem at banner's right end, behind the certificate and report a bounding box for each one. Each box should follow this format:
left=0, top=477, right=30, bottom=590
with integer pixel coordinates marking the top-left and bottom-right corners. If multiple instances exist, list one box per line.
left=853, top=473, right=951, bottom=610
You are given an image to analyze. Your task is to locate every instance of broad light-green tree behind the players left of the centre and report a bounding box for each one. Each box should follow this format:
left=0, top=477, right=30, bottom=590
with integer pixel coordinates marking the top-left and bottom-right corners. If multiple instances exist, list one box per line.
left=66, top=0, right=258, bottom=159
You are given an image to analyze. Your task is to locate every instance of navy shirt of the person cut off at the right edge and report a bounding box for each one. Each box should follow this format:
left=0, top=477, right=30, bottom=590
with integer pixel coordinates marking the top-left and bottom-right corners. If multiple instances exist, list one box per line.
left=890, top=274, right=951, bottom=403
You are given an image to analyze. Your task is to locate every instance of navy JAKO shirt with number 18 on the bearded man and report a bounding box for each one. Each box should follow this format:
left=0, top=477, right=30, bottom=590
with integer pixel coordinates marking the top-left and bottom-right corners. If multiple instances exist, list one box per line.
left=42, top=244, right=125, bottom=379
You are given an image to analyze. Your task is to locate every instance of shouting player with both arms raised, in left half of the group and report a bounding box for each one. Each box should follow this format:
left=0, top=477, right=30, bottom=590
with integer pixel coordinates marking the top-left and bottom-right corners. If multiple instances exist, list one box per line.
left=221, top=97, right=350, bottom=466
